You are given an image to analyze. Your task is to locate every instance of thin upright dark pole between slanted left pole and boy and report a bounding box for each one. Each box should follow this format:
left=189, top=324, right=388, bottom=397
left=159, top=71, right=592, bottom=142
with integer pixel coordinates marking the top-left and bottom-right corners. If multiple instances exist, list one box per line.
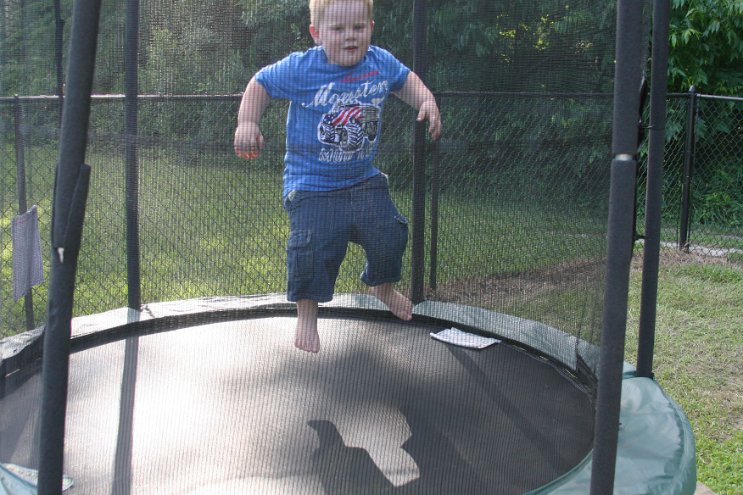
left=124, top=0, right=142, bottom=309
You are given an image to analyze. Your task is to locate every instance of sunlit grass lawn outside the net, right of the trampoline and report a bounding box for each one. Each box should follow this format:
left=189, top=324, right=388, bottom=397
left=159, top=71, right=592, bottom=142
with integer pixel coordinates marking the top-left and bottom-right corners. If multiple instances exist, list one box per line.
left=626, top=250, right=743, bottom=495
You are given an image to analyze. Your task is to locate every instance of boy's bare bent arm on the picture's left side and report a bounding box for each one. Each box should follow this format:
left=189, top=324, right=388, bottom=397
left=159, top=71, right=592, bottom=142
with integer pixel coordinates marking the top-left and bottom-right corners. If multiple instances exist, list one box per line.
left=234, top=77, right=271, bottom=159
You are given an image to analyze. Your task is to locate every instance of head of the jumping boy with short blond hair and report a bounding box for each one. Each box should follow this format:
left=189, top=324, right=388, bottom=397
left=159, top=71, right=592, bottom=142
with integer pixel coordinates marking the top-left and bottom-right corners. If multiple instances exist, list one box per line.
left=310, top=0, right=374, bottom=67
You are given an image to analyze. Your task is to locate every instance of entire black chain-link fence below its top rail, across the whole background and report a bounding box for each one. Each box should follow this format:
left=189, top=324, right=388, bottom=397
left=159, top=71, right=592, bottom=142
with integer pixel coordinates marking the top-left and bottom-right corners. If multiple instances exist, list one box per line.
left=0, top=93, right=743, bottom=340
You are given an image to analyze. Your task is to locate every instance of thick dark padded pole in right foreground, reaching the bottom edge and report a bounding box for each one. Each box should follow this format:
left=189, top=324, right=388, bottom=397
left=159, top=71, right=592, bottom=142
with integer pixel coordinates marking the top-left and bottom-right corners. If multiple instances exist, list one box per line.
left=591, top=0, right=644, bottom=495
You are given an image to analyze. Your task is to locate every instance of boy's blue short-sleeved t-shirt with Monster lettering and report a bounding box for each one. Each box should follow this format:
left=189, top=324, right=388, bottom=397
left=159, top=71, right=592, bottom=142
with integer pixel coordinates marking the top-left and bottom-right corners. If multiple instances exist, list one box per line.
left=255, top=46, right=410, bottom=195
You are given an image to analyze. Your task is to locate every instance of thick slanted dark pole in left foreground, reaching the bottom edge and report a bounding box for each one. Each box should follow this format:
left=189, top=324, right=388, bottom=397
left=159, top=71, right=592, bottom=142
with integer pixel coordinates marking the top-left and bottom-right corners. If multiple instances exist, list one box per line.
left=38, top=0, right=100, bottom=495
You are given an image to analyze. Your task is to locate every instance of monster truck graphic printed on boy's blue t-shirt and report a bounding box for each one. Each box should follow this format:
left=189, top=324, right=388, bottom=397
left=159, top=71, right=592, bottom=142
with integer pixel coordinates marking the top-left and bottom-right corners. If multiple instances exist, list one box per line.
left=317, top=103, right=379, bottom=151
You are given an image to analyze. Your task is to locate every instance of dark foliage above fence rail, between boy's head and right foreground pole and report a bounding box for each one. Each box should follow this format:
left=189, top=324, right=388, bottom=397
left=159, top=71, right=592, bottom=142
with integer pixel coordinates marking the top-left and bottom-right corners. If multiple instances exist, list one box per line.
left=375, top=0, right=614, bottom=92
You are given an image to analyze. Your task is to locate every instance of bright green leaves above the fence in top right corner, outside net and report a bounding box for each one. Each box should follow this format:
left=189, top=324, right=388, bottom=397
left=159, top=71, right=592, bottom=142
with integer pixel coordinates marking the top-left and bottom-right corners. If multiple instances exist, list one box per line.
left=668, top=0, right=743, bottom=95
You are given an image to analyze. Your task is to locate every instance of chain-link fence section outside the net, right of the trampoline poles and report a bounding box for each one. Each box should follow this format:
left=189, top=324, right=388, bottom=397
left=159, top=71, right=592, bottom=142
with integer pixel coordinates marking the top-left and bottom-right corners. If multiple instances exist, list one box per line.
left=638, top=89, right=743, bottom=262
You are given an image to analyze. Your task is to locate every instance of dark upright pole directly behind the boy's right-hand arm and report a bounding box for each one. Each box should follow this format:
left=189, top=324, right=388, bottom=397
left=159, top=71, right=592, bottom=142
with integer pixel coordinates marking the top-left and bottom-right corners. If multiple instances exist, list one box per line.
left=410, top=0, right=426, bottom=304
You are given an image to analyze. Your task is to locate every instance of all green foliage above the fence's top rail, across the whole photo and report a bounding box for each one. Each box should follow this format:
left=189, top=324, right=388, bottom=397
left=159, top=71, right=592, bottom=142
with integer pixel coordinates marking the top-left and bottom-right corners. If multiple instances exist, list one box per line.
left=0, top=0, right=743, bottom=99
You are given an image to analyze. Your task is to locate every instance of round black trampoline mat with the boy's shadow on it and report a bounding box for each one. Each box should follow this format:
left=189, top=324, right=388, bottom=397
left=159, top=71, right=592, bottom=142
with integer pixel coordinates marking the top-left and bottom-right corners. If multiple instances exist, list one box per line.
left=0, top=317, right=593, bottom=495
